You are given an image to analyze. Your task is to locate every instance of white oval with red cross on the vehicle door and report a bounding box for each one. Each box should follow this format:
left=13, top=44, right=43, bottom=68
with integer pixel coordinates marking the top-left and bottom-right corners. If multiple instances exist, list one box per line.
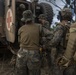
left=6, top=9, right=13, bottom=31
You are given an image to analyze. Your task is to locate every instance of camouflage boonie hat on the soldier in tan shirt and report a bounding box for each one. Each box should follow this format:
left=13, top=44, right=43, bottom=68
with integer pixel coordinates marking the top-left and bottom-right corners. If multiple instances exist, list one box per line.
left=21, top=10, right=34, bottom=22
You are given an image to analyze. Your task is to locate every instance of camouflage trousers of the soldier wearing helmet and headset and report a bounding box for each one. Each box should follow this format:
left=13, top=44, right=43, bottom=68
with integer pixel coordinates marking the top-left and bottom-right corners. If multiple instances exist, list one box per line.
left=51, top=48, right=63, bottom=75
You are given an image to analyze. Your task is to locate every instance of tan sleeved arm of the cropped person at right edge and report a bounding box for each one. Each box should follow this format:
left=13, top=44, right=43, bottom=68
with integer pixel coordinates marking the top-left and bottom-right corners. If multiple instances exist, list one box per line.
left=64, top=23, right=76, bottom=60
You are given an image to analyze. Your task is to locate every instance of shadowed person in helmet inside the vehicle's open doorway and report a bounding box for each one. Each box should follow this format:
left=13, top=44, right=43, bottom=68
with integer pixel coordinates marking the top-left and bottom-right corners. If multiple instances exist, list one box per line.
left=16, top=4, right=26, bottom=42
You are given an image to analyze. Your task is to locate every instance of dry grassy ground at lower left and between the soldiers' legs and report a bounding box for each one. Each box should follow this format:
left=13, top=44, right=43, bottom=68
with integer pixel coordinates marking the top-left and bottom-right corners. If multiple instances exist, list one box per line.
left=0, top=55, right=50, bottom=75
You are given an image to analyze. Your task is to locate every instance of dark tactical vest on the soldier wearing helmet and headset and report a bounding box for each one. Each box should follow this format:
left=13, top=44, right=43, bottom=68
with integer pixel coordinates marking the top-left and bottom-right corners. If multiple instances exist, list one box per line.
left=56, top=24, right=69, bottom=55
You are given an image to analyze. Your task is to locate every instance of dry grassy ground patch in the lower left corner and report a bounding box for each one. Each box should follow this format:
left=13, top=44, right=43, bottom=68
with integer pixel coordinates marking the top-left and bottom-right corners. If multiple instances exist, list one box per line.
left=0, top=54, right=14, bottom=75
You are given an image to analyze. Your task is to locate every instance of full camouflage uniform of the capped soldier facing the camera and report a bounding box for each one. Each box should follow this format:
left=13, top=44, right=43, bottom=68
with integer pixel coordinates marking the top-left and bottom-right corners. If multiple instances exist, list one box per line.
left=42, top=26, right=53, bottom=67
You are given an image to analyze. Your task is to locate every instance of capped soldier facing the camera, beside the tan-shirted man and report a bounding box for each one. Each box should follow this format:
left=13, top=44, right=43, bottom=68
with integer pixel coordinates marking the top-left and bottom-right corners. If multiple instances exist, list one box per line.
left=39, top=14, right=52, bottom=48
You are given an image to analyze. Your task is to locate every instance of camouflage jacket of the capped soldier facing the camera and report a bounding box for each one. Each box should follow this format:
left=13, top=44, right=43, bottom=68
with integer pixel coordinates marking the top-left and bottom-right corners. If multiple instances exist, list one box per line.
left=41, top=21, right=53, bottom=49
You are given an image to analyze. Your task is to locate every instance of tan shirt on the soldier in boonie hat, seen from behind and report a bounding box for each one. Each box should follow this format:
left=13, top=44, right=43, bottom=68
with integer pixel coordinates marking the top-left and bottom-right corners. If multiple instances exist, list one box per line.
left=18, top=23, right=41, bottom=50
